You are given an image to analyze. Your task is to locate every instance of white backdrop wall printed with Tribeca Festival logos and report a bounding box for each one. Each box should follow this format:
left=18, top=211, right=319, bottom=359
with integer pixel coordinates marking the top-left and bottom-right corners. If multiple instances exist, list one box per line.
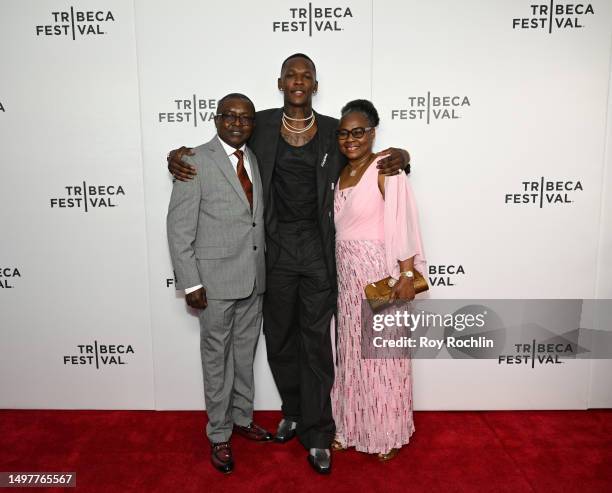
left=0, top=0, right=612, bottom=409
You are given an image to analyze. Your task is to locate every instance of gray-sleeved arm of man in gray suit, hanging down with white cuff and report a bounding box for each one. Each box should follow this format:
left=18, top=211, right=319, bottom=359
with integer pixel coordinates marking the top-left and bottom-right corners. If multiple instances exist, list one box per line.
left=166, top=152, right=207, bottom=309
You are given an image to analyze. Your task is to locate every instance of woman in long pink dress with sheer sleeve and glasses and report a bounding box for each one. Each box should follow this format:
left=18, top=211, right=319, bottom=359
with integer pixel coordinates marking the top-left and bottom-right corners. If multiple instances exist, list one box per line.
left=332, top=100, right=425, bottom=460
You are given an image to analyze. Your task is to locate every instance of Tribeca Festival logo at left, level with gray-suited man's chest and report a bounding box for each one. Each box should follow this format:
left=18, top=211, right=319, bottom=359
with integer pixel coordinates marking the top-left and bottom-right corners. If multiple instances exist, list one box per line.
left=49, top=182, right=125, bottom=212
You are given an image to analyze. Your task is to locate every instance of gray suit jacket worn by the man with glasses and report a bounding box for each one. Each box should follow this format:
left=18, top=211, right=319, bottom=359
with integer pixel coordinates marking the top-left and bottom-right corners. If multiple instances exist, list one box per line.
left=167, top=136, right=266, bottom=299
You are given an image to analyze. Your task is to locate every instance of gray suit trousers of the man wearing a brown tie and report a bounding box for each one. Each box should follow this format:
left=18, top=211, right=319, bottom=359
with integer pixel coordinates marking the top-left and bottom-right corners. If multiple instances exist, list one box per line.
left=200, top=280, right=263, bottom=443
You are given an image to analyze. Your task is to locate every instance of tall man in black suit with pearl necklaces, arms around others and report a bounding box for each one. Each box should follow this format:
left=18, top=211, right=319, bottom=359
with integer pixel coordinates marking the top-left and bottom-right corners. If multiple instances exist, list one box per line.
left=168, top=53, right=410, bottom=474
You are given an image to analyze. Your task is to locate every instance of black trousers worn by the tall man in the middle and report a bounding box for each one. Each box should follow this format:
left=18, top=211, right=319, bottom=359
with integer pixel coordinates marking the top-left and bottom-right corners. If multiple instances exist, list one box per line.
left=263, top=223, right=336, bottom=449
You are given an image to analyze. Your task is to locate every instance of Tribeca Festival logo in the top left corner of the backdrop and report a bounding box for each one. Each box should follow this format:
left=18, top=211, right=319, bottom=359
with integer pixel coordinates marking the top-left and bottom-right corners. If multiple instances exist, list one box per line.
left=36, top=7, right=115, bottom=41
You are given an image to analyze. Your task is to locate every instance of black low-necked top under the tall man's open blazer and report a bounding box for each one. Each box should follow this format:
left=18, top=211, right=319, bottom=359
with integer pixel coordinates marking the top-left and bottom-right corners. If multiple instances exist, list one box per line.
left=272, top=133, right=318, bottom=223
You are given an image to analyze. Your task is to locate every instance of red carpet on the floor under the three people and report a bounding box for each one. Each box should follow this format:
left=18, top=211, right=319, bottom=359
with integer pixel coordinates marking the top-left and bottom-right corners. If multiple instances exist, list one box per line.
left=0, top=410, right=612, bottom=493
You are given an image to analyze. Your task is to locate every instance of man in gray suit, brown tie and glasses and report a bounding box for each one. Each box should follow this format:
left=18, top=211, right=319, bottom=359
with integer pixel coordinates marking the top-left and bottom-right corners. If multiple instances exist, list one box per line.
left=167, top=93, right=272, bottom=473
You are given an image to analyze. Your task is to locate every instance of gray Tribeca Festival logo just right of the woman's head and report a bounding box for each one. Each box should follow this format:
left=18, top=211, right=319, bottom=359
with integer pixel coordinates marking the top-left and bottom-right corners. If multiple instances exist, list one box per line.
left=391, top=91, right=472, bottom=125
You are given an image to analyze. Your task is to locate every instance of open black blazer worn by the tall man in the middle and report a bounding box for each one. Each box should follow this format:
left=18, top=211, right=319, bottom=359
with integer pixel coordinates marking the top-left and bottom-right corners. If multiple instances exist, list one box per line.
left=248, top=108, right=346, bottom=290
